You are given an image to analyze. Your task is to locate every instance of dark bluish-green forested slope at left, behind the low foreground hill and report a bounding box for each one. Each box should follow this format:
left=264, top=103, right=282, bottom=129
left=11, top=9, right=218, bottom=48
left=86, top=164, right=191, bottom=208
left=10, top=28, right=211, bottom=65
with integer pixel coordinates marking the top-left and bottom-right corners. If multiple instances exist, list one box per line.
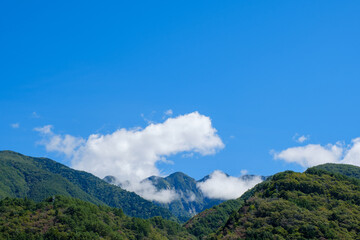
left=0, top=151, right=173, bottom=219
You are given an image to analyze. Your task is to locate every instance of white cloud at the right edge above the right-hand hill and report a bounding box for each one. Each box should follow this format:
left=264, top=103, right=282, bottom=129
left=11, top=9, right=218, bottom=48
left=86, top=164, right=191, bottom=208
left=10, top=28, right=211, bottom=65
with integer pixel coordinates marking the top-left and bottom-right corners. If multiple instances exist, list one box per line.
left=273, top=138, right=360, bottom=167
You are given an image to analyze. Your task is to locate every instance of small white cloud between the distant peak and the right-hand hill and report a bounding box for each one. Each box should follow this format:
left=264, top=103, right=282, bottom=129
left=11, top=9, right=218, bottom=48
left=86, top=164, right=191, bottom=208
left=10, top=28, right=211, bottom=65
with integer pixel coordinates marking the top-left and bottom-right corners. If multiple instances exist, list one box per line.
left=197, top=170, right=262, bottom=200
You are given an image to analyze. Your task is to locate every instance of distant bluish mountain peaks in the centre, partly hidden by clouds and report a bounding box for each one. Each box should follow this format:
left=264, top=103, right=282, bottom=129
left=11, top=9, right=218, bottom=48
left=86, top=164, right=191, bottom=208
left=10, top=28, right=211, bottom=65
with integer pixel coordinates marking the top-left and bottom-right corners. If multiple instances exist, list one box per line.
left=104, top=172, right=266, bottom=222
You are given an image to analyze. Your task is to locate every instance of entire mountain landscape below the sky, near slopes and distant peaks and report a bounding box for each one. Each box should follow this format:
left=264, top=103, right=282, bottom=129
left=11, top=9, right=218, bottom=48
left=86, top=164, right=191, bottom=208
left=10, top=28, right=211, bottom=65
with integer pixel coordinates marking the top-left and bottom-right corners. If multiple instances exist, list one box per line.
left=0, top=151, right=360, bottom=239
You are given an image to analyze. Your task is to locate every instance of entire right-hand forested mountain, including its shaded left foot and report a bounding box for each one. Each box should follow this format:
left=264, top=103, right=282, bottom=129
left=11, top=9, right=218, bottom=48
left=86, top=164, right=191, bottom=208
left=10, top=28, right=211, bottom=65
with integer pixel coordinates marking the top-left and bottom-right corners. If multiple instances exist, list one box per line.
left=184, top=164, right=360, bottom=239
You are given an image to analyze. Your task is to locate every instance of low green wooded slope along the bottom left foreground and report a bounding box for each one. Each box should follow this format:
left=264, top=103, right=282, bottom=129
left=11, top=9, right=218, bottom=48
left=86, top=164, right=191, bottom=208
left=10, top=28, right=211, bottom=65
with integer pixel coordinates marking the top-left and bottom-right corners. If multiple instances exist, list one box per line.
left=0, top=196, right=194, bottom=240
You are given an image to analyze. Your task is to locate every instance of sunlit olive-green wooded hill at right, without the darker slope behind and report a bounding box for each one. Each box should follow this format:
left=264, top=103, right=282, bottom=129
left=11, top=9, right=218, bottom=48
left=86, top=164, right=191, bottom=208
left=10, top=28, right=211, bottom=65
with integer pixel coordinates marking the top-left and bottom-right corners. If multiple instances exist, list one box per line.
left=214, top=169, right=360, bottom=239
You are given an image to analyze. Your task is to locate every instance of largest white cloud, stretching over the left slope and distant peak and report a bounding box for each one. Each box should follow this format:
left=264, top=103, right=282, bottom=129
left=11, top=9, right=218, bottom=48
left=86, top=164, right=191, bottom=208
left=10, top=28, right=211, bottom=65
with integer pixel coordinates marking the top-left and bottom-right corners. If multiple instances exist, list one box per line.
left=35, top=112, right=224, bottom=201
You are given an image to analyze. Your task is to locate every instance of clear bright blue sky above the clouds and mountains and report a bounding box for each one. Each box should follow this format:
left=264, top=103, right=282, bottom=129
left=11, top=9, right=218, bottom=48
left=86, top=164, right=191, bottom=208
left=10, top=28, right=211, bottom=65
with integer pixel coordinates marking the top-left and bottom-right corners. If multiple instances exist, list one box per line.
left=0, top=1, right=360, bottom=179
